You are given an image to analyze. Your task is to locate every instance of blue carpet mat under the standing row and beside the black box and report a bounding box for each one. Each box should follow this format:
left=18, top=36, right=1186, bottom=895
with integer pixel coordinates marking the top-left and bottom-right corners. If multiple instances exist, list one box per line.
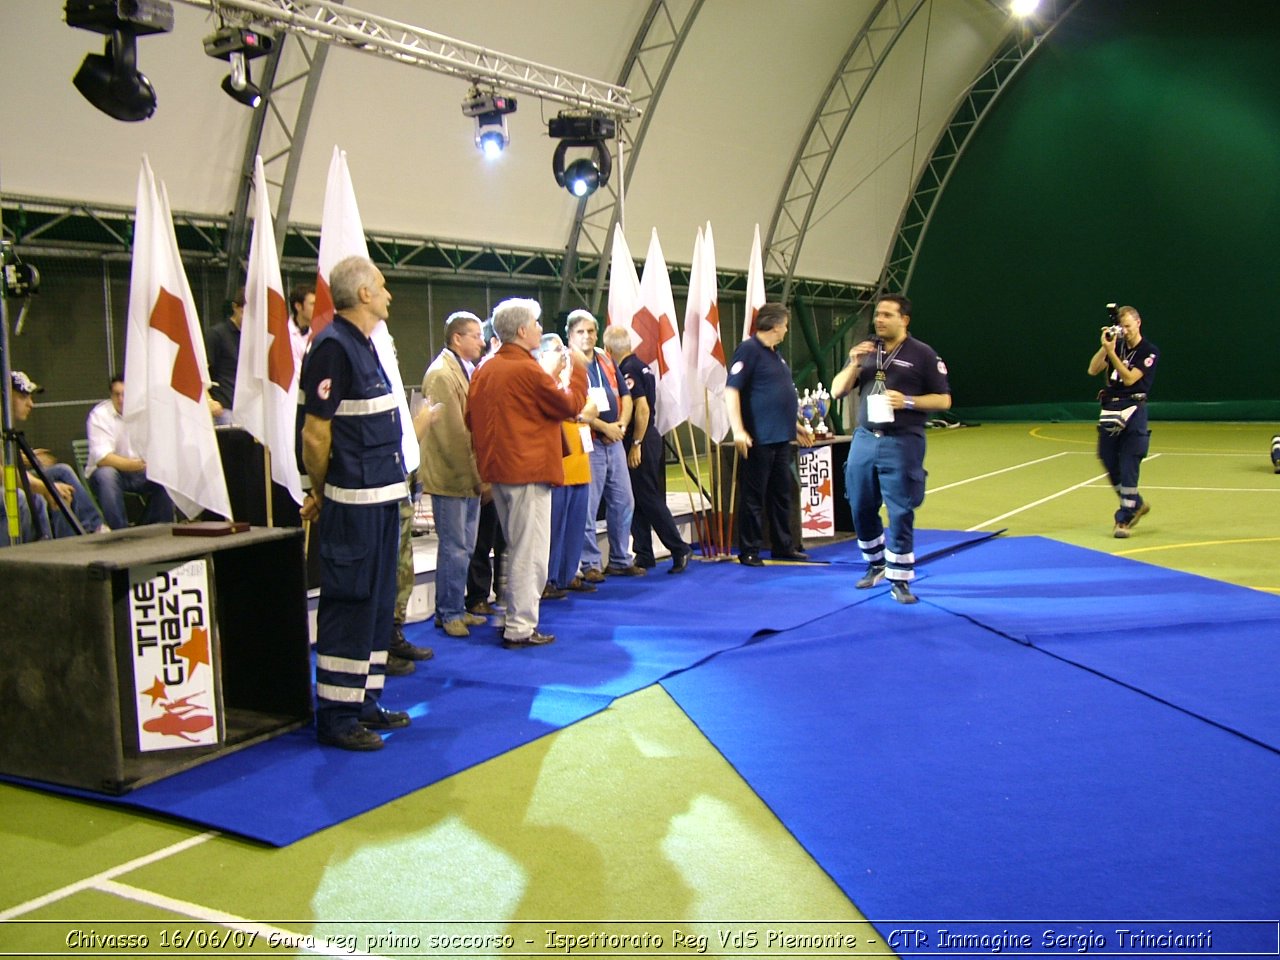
left=5, top=531, right=974, bottom=846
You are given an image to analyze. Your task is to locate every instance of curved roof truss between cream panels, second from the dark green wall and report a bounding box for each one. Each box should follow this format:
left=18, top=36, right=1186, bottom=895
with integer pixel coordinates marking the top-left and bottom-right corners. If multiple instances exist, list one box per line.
left=763, top=0, right=924, bottom=302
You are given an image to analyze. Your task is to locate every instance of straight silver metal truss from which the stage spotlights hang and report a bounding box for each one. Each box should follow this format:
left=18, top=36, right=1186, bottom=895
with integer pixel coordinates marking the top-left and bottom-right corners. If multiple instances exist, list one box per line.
left=172, top=0, right=639, bottom=120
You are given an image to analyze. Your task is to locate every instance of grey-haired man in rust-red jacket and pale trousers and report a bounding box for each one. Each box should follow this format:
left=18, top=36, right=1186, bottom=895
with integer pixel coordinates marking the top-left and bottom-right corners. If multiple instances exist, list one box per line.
left=466, top=300, right=586, bottom=649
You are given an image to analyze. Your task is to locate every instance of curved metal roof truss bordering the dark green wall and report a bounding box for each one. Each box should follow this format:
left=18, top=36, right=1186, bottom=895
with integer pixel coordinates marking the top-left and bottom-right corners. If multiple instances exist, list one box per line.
left=879, top=0, right=1079, bottom=291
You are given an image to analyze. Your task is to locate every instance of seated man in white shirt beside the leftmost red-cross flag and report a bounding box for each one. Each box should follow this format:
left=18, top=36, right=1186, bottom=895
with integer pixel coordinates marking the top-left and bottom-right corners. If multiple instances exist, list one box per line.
left=84, top=374, right=173, bottom=530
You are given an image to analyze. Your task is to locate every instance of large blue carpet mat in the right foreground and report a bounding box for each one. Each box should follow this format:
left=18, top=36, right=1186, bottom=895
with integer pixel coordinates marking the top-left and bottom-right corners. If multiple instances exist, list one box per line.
left=663, top=601, right=1280, bottom=926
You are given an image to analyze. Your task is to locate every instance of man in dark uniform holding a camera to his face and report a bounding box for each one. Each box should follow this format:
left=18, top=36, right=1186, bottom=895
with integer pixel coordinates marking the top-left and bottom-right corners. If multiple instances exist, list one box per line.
left=1089, top=303, right=1160, bottom=539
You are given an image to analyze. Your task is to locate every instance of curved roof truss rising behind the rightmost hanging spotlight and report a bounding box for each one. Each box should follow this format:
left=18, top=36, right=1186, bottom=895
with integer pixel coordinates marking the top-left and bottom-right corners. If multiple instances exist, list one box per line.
left=559, top=0, right=704, bottom=314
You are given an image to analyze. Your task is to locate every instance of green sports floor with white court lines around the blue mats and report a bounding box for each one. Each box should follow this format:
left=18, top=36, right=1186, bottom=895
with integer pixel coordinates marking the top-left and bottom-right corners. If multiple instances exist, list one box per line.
left=0, top=422, right=1280, bottom=957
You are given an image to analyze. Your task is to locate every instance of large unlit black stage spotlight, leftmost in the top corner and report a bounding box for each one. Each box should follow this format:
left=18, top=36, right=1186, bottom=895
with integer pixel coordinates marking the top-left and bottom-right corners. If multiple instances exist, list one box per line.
left=64, top=0, right=173, bottom=123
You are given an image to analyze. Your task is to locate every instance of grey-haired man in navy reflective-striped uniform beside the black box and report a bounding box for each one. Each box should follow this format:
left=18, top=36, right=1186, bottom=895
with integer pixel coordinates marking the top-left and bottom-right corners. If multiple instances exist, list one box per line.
left=298, top=256, right=408, bottom=750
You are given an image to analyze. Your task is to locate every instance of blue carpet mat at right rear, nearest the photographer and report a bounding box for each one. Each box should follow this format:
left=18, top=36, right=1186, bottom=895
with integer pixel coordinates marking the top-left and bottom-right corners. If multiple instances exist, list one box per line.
left=919, top=536, right=1280, bottom=750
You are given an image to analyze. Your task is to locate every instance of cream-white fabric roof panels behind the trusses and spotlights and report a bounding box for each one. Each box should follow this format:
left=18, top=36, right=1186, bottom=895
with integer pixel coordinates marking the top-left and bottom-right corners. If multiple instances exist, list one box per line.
left=0, top=0, right=1010, bottom=283
